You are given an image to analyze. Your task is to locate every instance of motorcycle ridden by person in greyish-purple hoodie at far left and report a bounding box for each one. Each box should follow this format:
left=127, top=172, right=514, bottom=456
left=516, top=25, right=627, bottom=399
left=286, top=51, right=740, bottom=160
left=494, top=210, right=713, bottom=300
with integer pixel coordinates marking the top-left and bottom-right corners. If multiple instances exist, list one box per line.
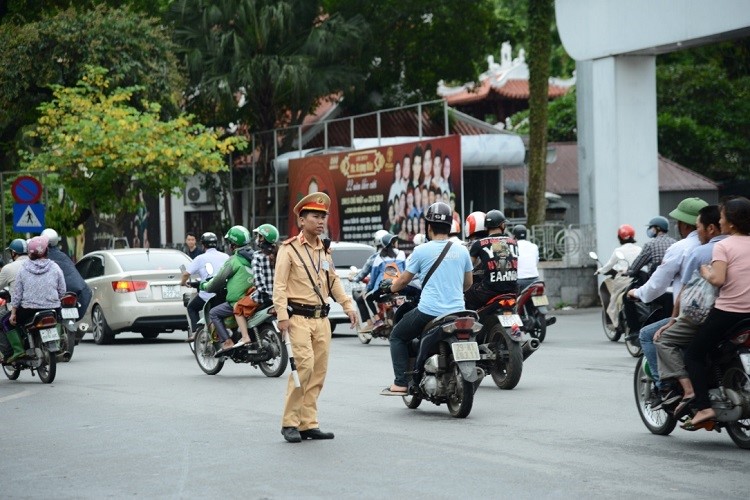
left=0, top=291, right=61, bottom=384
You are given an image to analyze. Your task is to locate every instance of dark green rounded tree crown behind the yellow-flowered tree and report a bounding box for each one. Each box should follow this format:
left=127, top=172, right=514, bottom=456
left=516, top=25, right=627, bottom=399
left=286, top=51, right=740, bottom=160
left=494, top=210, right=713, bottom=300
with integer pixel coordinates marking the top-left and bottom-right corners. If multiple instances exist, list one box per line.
left=0, top=6, right=185, bottom=169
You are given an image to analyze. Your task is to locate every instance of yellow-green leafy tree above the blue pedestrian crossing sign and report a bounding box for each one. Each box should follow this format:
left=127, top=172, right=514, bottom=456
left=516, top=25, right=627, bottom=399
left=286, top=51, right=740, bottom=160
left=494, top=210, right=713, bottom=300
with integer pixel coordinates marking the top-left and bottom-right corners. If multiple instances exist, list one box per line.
left=20, top=68, right=245, bottom=231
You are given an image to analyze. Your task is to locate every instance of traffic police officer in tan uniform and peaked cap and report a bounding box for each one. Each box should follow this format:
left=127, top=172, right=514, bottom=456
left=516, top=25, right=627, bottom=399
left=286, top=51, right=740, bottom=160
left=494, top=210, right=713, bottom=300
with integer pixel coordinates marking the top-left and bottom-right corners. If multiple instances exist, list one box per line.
left=273, top=193, right=357, bottom=443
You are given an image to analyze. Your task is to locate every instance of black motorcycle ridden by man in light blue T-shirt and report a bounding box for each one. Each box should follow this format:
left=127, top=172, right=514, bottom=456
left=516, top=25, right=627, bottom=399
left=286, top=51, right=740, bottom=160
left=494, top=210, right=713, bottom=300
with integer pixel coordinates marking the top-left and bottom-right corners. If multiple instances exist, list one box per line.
left=402, top=311, right=484, bottom=418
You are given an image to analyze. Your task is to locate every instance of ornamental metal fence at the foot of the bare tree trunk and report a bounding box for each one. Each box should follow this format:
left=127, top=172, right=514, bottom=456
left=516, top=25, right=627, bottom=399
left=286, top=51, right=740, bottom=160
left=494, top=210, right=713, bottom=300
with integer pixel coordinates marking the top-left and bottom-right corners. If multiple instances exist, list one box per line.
left=528, top=222, right=596, bottom=266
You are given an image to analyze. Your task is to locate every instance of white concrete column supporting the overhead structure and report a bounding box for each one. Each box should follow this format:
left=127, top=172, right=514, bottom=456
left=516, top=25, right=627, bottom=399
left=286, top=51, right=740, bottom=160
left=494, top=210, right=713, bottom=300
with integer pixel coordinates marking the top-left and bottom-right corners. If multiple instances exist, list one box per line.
left=576, top=56, right=659, bottom=260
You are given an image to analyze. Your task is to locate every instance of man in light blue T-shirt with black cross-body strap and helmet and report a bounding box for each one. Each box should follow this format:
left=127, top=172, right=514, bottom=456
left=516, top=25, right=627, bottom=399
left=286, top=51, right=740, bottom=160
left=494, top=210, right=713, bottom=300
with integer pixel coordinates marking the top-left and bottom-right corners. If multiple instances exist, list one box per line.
left=380, top=202, right=472, bottom=396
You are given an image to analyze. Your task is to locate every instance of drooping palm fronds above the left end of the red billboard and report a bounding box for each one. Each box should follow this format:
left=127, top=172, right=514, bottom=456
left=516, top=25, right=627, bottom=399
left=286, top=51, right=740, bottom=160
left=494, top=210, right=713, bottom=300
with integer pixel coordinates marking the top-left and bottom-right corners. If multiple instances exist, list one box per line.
left=169, top=0, right=366, bottom=132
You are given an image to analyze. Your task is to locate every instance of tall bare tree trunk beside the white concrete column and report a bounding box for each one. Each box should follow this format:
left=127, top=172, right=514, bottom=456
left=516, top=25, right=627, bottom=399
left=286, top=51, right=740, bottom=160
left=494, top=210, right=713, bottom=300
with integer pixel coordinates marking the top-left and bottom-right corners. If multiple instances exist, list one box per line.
left=527, top=0, right=553, bottom=225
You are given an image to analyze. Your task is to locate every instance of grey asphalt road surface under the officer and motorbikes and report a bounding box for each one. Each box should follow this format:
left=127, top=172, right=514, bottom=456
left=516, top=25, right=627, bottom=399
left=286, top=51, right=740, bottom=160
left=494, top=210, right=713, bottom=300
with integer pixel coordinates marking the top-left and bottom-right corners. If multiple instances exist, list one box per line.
left=0, top=310, right=750, bottom=499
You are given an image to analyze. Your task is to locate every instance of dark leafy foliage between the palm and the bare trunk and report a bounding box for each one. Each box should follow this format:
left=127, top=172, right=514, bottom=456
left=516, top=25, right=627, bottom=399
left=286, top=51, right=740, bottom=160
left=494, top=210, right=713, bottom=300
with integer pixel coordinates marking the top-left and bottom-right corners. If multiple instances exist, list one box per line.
left=324, top=0, right=502, bottom=111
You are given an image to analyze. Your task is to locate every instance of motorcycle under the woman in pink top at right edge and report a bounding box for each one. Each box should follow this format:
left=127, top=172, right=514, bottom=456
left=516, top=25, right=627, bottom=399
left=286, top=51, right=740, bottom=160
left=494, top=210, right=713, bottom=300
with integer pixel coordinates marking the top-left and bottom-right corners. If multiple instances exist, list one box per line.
left=633, top=319, right=750, bottom=450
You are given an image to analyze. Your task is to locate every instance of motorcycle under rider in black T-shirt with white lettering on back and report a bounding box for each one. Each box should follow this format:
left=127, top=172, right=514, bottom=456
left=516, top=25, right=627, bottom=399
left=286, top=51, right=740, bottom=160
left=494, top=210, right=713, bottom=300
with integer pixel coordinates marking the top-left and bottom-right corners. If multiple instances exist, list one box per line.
left=477, top=293, right=541, bottom=390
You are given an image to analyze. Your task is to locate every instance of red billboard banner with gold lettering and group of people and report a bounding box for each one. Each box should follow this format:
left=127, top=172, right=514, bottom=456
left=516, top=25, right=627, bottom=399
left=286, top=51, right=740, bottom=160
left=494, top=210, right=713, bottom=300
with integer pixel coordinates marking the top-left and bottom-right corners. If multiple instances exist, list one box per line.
left=289, top=136, right=461, bottom=248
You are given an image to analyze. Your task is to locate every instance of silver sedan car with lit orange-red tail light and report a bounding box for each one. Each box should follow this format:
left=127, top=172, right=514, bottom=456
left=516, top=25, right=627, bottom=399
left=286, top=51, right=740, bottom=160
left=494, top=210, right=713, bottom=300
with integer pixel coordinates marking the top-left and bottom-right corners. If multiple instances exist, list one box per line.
left=76, top=248, right=190, bottom=344
